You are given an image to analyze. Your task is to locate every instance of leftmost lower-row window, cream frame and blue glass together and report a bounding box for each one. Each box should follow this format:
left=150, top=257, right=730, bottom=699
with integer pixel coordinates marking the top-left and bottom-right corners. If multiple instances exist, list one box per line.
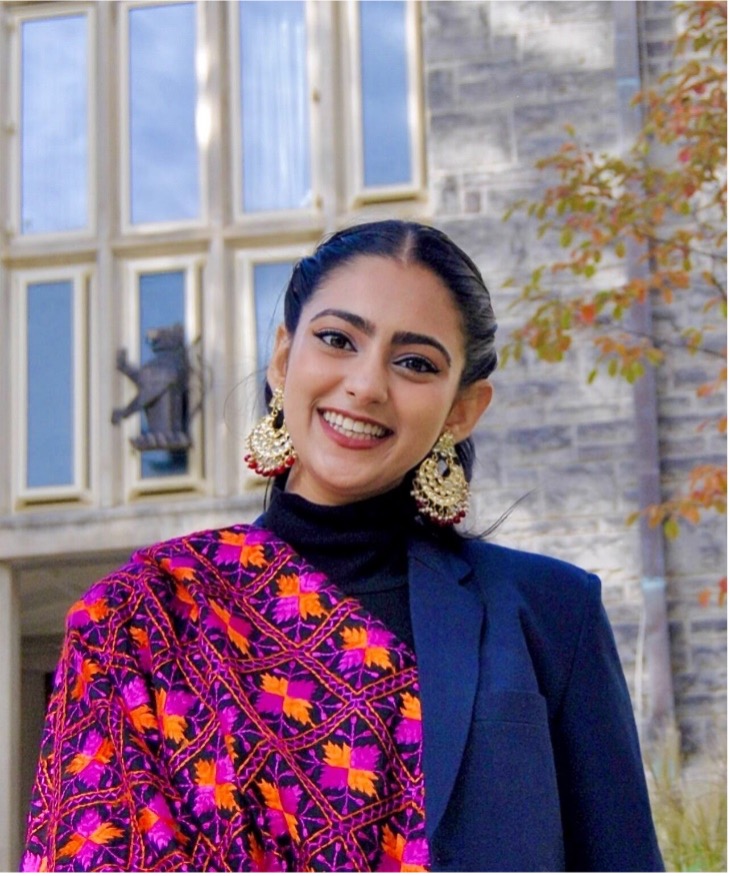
left=14, top=269, right=89, bottom=503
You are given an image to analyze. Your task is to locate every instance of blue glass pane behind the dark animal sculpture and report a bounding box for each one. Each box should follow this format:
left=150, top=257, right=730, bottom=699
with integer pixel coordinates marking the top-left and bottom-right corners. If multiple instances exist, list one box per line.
left=139, top=271, right=188, bottom=478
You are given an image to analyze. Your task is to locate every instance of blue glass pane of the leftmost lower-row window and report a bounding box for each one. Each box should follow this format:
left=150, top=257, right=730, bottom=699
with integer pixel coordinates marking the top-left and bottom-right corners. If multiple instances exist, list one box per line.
left=26, top=280, right=75, bottom=487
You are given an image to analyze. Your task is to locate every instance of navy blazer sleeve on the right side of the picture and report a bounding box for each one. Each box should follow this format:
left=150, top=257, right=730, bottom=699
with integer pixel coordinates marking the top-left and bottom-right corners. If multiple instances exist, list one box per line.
left=552, top=575, right=664, bottom=872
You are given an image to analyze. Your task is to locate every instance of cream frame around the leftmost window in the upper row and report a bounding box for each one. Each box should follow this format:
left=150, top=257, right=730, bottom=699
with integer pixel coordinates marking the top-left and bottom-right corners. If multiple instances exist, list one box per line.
left=7, top=3, right=98, bottom=243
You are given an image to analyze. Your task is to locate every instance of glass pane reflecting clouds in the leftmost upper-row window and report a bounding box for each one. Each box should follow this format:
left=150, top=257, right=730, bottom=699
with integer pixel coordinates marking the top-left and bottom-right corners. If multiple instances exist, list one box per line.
left=20, top=15, right=89, bottom=234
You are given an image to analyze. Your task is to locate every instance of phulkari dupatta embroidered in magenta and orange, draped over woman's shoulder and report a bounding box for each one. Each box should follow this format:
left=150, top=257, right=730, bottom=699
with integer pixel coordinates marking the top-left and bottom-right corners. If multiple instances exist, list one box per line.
left=22, top=526, right=429, bottom=872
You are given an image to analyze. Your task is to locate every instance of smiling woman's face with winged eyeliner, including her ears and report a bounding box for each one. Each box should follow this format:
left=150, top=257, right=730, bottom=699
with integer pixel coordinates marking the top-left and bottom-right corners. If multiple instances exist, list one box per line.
left=268, top=256, right=491, bottom=505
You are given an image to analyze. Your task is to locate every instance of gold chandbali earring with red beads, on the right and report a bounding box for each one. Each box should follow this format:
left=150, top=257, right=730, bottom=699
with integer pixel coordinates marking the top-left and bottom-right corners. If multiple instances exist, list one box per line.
left=411, top=430, right=469, bottom=526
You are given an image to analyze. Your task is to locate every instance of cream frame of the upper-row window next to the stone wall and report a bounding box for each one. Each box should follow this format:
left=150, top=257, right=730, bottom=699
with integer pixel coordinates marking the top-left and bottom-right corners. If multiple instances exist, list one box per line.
left=337, top=0, right=426, bottom=209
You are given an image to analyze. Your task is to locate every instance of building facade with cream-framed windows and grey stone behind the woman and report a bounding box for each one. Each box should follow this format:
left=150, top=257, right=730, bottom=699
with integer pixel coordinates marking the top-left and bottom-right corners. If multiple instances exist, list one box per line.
left=0, top=0, right=725, bottom=869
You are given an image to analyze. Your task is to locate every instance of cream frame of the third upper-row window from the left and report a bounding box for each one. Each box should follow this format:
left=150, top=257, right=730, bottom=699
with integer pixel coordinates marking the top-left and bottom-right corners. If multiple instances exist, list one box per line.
left=225, top=0, right=324, bottom=233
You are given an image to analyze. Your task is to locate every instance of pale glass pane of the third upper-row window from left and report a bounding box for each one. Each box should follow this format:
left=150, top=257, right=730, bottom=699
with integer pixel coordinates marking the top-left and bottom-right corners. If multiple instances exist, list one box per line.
left=239, top=0, right=312, bottom=212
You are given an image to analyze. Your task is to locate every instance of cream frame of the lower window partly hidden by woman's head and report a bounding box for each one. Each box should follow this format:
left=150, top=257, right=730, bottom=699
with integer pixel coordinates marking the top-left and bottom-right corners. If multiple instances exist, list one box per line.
left=233, top=243, right=314, bottom=490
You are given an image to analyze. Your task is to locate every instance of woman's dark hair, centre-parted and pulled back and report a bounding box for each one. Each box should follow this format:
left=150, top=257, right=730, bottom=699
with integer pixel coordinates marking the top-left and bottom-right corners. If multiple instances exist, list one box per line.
left=266, top=219, right=497, bottom=479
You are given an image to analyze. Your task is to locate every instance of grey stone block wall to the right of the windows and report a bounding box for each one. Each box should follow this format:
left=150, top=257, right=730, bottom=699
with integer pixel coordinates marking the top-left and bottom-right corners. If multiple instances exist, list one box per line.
left=422, top=0, right=726, bottom=752
